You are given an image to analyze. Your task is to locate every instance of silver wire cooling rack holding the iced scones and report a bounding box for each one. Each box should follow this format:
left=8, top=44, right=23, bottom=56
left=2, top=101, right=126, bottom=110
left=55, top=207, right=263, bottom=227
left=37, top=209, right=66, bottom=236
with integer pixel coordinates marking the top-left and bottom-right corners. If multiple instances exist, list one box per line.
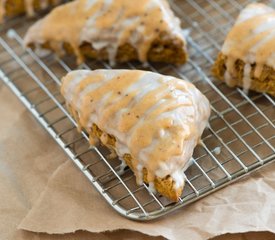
left=0, top=0, right=275, bottom=220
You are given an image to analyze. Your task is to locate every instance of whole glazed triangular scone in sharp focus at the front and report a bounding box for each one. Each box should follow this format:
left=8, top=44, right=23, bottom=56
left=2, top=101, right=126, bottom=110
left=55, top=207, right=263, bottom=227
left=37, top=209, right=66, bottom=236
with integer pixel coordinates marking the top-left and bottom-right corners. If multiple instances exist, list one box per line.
left=61, top=70, right=210, bottom=201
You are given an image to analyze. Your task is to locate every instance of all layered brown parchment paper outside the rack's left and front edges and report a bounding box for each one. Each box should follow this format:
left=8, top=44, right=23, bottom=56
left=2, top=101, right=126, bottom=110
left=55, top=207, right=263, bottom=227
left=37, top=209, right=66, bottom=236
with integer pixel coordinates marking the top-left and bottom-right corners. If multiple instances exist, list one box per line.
left=0, top=79, right=275, bottom=240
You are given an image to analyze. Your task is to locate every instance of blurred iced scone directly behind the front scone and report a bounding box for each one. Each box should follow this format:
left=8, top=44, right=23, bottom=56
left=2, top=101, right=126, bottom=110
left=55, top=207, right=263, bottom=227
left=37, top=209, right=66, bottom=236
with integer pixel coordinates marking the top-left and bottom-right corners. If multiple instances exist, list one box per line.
left=25, top=0, right=187, bottom=64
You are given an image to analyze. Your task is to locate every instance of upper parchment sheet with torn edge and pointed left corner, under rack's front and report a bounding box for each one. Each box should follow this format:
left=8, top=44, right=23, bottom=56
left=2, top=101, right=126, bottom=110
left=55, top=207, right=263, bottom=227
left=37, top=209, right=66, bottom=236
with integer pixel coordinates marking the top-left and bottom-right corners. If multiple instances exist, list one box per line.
left=19, top=161, right=275, bottom=240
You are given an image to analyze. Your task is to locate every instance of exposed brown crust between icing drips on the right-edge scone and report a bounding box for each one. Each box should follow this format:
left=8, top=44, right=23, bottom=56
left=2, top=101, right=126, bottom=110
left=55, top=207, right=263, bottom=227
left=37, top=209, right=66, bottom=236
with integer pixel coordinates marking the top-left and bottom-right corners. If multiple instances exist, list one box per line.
left=212, top=53, right=275, bottom=96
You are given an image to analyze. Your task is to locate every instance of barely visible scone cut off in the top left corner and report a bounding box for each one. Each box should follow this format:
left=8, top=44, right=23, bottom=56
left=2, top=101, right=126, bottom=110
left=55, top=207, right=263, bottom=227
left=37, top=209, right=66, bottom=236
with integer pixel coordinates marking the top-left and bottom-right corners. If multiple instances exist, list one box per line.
left=0, top=0, right=62, bottom=23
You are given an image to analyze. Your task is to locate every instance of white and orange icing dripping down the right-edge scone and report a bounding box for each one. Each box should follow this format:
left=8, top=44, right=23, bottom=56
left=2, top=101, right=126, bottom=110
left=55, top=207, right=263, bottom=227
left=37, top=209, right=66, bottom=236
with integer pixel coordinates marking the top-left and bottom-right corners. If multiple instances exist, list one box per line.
left=222, top=3, right=275, bottom=91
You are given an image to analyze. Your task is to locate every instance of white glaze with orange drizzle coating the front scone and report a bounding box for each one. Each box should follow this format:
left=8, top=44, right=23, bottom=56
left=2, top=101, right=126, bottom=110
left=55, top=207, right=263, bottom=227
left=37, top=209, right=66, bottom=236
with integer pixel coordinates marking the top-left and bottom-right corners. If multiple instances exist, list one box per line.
left=61, top=70, right=210, bottom=191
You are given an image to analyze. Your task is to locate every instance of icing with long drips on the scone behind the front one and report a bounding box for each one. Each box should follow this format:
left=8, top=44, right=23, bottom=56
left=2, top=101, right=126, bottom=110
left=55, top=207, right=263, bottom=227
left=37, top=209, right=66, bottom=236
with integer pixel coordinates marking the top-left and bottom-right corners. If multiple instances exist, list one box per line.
left=25, top=0, right=188, bottom=63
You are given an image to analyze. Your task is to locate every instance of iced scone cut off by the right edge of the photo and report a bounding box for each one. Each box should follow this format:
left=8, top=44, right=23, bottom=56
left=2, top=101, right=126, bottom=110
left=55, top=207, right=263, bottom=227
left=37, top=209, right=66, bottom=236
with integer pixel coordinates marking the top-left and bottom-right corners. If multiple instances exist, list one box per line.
left=213, top=3, right=275, bottom=96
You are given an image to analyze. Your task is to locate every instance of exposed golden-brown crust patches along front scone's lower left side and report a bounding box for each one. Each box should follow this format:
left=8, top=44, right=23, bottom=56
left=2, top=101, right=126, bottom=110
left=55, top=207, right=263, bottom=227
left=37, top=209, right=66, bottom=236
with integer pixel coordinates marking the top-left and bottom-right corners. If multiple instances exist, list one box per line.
left=68, top=106, right=183, bottom=202
